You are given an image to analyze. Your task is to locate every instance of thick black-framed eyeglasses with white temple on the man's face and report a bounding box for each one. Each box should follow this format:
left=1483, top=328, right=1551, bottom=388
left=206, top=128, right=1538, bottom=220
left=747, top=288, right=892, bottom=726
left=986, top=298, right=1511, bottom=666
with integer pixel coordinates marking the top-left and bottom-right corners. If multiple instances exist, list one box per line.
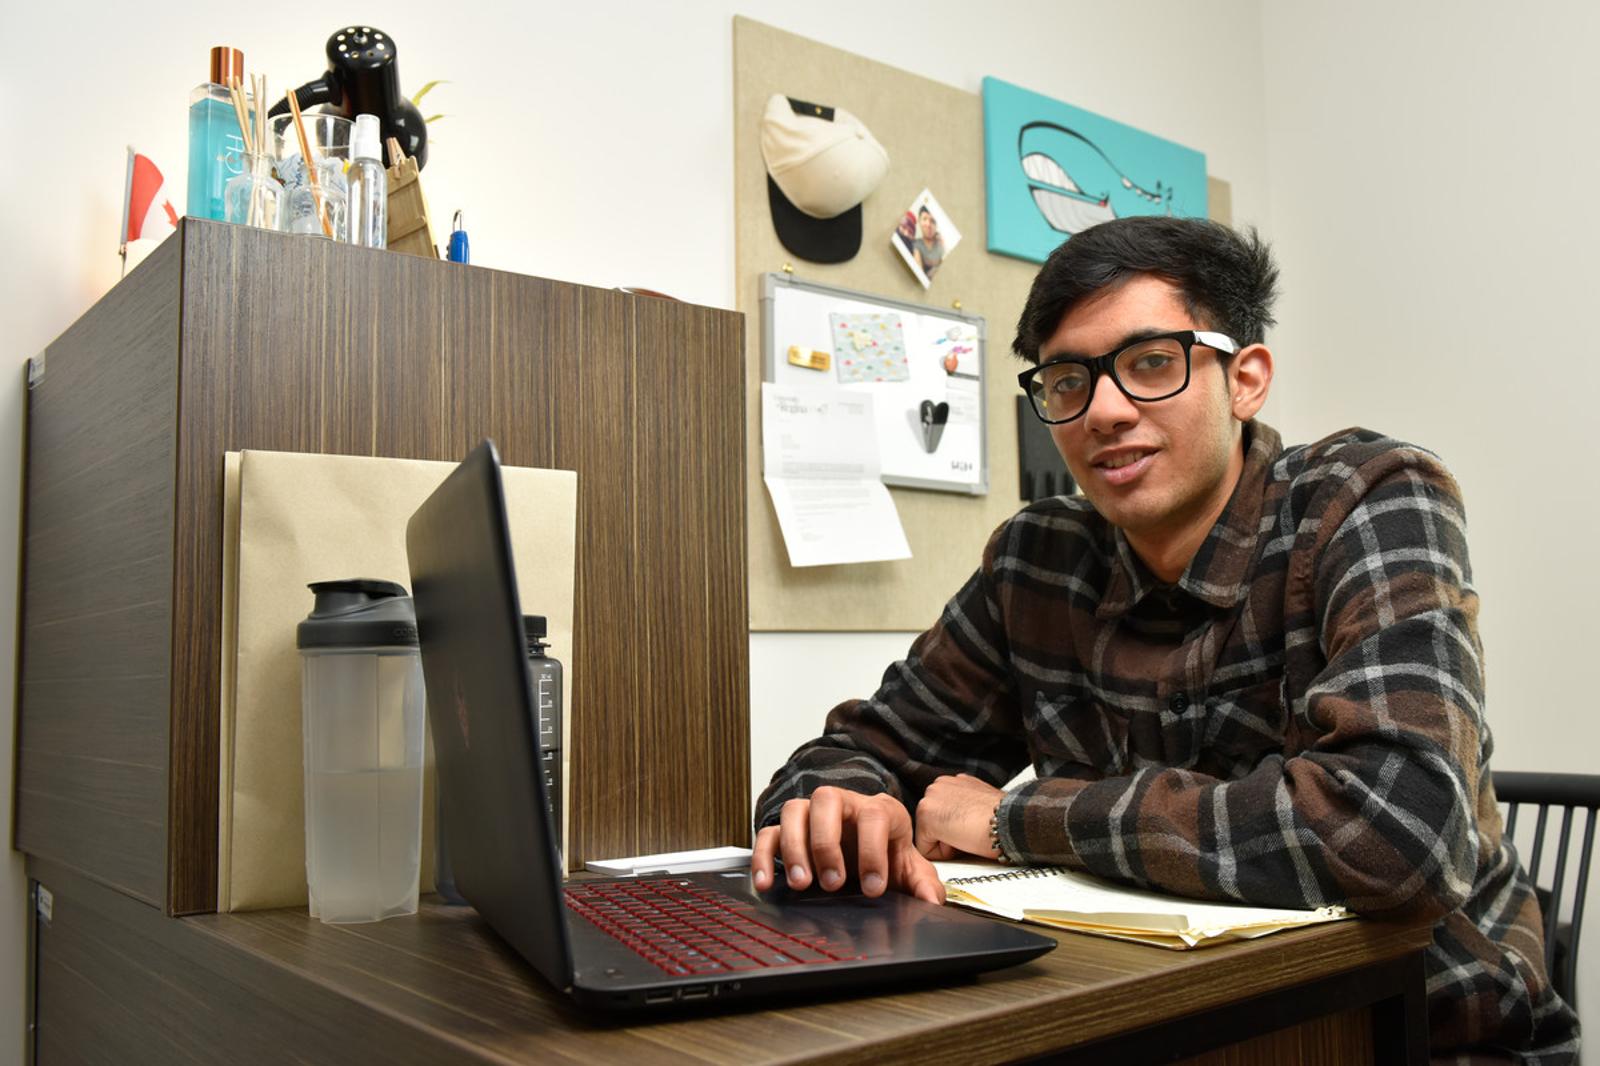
left=1016, top=330, right=1238, bottom=426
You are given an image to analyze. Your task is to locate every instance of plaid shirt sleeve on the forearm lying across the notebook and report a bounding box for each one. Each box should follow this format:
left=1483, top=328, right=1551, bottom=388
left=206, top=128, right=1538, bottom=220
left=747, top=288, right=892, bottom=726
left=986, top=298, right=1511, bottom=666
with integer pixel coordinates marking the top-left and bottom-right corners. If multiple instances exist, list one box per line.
left=1000, top=448, right=1486, bottom=916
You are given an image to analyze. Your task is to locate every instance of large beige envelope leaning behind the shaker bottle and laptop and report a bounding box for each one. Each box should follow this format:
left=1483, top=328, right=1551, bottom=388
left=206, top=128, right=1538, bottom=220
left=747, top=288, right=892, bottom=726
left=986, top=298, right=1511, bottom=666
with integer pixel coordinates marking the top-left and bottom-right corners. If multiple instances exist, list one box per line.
left=218, top=451, right=578, bottom=911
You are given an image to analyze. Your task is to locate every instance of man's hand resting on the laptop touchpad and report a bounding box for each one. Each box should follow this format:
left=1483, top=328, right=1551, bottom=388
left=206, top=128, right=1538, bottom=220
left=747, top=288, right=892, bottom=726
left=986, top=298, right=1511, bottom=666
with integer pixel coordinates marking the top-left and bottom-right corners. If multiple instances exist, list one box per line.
left=750, top=786, right=944, bottom=903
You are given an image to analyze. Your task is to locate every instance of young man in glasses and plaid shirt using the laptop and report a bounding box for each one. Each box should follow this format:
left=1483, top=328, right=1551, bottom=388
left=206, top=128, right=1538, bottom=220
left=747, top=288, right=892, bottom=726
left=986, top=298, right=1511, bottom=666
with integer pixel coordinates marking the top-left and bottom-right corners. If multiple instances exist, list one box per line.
left=752, top=218, right=1578, bottom=1063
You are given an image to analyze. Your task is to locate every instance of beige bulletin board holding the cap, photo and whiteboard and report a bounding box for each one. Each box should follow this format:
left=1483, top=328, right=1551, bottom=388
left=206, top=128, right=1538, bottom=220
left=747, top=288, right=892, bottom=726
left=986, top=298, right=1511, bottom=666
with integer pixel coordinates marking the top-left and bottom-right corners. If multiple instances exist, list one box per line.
left=733, top=18, right=1229, bottom=632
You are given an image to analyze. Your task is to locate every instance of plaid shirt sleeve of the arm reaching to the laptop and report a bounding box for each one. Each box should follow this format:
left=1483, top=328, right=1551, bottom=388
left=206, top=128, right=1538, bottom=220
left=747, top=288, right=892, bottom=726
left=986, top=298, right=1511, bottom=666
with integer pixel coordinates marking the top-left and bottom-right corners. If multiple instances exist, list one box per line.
left=755, top=525, right=1027, bottom=829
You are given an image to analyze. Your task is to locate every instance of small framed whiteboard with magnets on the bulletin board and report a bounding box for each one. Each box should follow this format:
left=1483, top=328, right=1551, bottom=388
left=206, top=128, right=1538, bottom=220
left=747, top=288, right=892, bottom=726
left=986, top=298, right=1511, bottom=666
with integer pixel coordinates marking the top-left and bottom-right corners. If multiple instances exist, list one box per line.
left=762, top=274, right=989, bottom=496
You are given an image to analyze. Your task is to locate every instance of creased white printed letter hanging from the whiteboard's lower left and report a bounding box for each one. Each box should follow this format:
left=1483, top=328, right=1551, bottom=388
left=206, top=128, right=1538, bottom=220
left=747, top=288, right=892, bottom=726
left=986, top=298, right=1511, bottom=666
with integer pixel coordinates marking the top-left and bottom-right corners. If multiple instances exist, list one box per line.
left=762, top=381, right=910, bottom=567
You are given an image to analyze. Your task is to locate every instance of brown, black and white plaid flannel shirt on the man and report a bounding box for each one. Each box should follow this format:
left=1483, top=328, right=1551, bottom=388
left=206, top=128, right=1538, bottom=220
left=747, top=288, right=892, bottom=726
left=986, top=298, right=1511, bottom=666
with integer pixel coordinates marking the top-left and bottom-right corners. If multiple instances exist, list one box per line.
left=757, top=423, right=1578, bottom=1063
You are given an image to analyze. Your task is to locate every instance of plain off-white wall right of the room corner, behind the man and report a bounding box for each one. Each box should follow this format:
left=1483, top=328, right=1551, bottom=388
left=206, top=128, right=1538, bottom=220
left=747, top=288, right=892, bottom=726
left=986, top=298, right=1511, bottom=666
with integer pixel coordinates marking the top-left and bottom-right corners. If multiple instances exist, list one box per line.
left=1262, top=0, right=1600, bottom=1020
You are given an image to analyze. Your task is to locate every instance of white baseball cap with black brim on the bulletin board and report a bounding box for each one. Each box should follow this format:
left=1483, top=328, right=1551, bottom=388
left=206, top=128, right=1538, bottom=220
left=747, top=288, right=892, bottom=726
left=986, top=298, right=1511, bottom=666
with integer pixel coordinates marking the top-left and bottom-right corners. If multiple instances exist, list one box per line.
left=762, top=94, right=890, bottom=262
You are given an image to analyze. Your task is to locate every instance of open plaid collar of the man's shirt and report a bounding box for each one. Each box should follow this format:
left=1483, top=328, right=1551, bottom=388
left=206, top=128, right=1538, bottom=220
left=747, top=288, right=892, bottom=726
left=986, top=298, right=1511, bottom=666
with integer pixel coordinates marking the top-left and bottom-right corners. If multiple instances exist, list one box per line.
left=1094, top=419, right=1283, bottom=619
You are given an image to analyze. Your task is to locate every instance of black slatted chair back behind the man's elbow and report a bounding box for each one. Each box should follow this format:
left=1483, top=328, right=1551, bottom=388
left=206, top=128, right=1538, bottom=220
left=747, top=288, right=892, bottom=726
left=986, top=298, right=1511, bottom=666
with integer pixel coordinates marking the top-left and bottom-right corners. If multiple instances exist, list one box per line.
left=1494, top=770, right=1600, bottom=1007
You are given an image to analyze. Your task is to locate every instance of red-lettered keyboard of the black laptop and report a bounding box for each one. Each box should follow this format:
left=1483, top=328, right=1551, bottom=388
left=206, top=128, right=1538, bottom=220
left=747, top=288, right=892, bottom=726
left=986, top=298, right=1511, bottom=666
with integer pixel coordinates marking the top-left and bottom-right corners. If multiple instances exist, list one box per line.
left=566, top=877, right=859, bottom=975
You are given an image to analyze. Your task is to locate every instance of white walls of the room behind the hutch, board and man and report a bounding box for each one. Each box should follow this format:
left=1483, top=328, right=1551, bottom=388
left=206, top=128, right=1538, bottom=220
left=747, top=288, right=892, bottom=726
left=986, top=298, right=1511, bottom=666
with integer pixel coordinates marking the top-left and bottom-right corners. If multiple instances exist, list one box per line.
left=25, top=0, right=1600, bottom=1063
